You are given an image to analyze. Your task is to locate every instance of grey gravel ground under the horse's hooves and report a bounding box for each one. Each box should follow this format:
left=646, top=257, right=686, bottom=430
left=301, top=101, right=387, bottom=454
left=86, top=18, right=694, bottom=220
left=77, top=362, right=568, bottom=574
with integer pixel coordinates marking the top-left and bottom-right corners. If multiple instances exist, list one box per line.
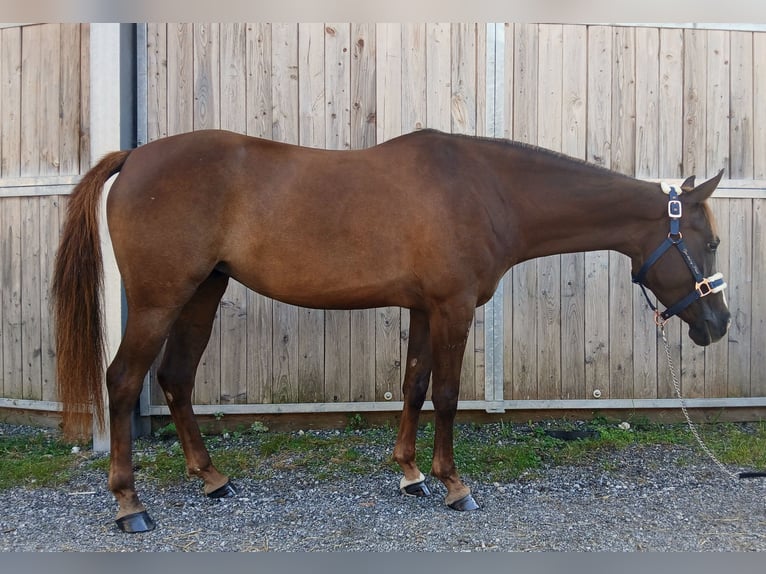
left=0, top=425, right=766, bottom=552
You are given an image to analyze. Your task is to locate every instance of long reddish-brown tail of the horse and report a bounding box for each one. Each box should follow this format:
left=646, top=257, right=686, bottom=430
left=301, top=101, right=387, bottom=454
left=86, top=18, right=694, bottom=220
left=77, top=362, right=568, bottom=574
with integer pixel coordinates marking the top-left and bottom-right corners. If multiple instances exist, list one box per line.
left=51, top=151, right=130, bottom=438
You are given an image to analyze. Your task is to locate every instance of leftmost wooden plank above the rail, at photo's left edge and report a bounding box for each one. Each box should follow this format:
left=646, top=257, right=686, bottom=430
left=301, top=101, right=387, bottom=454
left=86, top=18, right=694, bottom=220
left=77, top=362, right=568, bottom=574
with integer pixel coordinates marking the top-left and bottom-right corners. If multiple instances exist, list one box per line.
left=0, top=28, right=21, bottom=177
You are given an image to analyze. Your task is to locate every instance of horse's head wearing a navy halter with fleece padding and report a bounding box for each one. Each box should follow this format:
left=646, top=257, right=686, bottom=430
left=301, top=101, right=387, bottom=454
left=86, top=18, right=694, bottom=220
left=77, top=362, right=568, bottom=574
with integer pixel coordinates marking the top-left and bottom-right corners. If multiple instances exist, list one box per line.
left=633, top=171, right=731, bottom=345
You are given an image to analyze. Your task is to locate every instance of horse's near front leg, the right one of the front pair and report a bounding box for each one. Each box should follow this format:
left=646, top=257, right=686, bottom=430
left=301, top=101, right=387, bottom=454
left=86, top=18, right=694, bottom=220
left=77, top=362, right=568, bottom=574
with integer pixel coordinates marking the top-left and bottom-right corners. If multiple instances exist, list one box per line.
left=430, top=305, right=479, bottom=510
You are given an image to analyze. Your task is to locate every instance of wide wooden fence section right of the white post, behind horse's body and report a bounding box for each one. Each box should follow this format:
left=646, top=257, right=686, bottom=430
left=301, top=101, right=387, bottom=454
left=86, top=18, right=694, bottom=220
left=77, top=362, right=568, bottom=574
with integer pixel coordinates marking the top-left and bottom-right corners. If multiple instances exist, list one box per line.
left=147, top=24, right=766, bottom=414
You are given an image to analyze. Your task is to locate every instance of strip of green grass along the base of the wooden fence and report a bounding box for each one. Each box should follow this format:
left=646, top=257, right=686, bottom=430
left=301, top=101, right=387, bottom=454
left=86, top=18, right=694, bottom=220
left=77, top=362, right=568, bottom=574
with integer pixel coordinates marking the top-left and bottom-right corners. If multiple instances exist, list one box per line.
left=0, top=418, right=766, bottom=489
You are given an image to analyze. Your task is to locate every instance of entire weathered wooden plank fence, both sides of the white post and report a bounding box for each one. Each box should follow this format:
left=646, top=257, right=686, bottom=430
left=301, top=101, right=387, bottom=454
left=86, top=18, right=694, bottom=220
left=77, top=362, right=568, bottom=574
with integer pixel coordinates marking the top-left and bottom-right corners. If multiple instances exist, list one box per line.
left=0, top=23, right=766, bottom=432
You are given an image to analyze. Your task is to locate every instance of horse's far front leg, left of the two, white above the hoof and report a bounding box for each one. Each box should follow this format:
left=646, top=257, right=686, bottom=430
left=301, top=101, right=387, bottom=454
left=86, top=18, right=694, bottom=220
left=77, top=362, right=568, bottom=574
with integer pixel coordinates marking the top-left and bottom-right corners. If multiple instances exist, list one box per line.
left=394, top=309, right=431, bottom=496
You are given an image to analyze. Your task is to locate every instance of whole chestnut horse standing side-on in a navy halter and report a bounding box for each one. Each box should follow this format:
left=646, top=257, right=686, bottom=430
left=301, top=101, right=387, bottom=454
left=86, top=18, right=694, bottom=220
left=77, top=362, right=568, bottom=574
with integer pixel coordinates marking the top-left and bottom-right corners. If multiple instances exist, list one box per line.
left=53, top=130, right=729, bottom=532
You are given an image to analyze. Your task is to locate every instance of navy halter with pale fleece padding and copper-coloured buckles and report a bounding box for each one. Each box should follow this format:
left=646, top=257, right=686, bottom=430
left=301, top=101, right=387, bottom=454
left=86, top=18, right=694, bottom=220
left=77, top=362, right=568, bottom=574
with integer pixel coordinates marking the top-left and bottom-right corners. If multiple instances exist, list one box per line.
left=633, top=182, right=726, bottom=326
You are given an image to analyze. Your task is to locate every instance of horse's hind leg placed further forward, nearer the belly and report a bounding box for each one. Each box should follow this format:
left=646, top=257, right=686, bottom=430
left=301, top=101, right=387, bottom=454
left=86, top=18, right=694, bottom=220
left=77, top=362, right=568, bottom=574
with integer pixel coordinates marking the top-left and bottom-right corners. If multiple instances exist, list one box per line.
left=157, top=271, right=235, bottom=498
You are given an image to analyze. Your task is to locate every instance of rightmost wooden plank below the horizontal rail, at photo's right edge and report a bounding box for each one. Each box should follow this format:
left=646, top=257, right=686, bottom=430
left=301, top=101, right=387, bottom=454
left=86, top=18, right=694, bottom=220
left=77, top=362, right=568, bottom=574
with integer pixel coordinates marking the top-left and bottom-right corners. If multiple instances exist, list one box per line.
left=750, top=199, right=766, bottom=397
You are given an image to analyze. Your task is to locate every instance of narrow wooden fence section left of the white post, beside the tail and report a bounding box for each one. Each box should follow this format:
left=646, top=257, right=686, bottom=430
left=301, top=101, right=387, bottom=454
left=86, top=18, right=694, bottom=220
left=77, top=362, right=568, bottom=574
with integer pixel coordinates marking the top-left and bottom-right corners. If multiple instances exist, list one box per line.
left=0, top=24, right=90, bottom=409
